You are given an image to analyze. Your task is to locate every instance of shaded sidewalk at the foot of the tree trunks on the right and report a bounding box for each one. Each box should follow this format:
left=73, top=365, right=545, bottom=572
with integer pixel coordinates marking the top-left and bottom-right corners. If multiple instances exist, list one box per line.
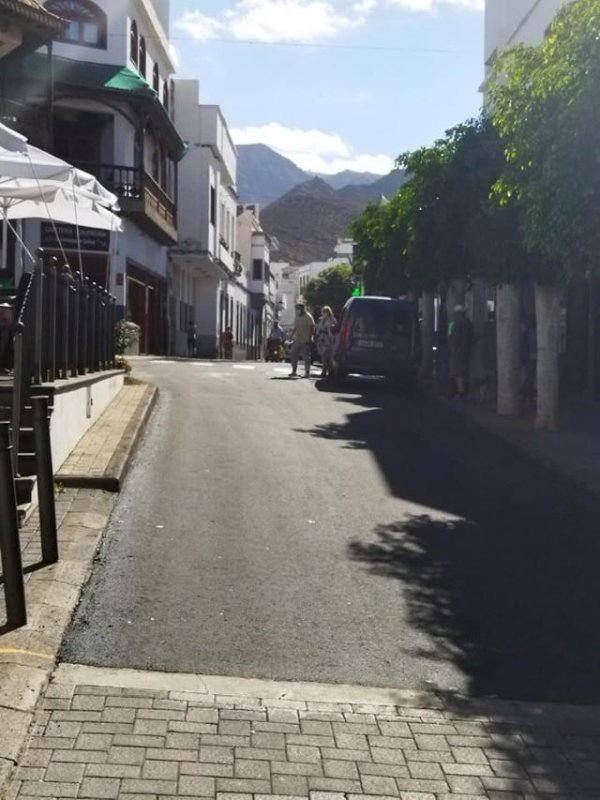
left=443, top=398, right=600, bottom=501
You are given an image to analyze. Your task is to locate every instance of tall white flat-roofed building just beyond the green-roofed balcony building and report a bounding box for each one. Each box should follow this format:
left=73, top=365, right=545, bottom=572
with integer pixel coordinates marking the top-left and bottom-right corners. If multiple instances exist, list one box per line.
left=170, top=80, right=253, bottom=358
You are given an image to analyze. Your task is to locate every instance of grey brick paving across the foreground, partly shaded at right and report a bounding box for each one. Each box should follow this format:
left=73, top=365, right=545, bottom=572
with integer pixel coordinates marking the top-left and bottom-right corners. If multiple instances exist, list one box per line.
left=8, top=665, right=600, bottom=800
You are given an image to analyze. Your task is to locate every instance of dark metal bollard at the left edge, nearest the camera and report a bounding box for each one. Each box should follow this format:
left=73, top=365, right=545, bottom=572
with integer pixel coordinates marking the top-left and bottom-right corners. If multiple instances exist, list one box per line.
left=0, top=422, right=27, bottom=627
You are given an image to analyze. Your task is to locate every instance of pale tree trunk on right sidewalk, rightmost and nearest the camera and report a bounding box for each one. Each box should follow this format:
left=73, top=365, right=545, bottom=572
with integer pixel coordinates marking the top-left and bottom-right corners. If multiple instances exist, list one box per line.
left=535, top=283, right=560, bottom=430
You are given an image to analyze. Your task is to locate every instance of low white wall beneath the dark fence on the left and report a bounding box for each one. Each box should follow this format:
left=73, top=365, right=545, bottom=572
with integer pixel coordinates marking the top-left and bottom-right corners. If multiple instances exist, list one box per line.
left=50, top=371, right=125, bottom=471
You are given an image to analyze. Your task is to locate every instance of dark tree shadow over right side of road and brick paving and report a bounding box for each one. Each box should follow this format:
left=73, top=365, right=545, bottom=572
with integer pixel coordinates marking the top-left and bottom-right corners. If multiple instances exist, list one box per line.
left=303, top=383, right=600, bottom=800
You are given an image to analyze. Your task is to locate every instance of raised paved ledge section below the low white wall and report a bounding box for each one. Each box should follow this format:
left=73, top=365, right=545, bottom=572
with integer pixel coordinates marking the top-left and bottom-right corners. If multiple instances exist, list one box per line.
left=57, top=383, right=148, bottom=480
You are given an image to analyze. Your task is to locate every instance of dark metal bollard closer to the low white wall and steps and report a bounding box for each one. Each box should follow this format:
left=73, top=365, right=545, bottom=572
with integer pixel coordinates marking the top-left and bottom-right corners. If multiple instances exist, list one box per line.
left=31, top=397, right=58, bottom=564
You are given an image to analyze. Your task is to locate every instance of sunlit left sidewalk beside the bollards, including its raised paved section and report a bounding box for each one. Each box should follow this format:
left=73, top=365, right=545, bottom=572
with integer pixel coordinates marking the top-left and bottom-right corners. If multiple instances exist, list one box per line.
left=0, top=385, right=155, bottom=797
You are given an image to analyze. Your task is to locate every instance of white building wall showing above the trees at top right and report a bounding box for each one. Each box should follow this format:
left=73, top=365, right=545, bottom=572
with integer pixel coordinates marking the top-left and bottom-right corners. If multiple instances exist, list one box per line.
left=483, top=0, right=571, bottom=92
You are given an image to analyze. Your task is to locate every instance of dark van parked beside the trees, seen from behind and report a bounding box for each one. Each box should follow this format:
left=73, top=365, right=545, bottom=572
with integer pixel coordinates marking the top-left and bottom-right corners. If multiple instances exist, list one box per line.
left=333, top=297, right=420, bottom=386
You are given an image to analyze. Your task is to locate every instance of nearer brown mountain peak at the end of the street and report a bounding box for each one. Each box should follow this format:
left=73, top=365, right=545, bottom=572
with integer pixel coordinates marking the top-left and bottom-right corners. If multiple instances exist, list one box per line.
left=261, top=178, right=366, bottom=264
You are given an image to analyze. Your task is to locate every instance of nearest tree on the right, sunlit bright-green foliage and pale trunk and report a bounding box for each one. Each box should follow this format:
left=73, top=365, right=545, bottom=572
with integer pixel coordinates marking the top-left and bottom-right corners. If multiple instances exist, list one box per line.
left=490, top=0, right=600, bottom=428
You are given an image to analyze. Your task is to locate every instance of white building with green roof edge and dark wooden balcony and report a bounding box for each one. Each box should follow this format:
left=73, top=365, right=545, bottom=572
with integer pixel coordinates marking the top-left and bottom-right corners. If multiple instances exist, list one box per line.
left=14, top=0, right=185, bottom=353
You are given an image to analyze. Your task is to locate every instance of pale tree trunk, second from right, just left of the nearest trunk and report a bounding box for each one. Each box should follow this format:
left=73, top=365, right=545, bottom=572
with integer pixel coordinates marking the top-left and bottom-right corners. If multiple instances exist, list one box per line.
left=496, top=283, right=521, bottom=416
